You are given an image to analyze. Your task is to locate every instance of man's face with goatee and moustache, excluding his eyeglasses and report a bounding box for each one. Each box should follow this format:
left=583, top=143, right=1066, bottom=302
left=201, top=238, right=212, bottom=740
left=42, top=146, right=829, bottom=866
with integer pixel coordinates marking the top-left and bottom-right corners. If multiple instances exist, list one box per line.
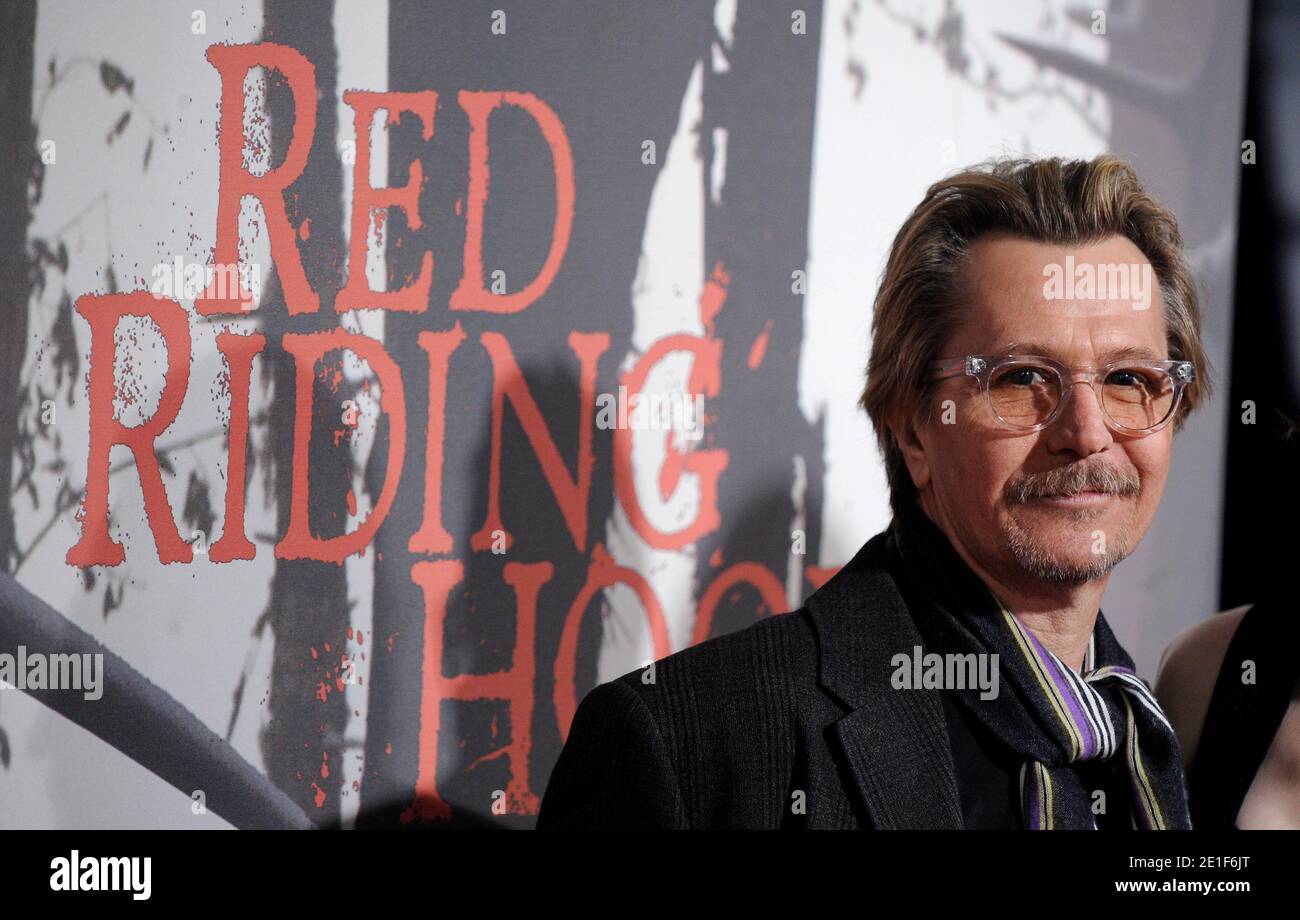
left=904, top=236, right=1173, bottom=583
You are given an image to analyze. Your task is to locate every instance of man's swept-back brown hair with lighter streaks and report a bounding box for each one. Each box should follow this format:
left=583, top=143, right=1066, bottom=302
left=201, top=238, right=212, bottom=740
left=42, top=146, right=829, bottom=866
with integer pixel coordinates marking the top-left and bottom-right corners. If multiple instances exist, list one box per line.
left=858, top=155, right=1210, bottom=513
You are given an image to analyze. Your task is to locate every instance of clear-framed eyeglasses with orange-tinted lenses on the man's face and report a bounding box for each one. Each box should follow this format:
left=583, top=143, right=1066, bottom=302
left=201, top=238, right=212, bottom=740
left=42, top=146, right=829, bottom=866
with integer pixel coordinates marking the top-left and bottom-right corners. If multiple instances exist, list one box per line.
left=927, top=355, right=1196, bottom=434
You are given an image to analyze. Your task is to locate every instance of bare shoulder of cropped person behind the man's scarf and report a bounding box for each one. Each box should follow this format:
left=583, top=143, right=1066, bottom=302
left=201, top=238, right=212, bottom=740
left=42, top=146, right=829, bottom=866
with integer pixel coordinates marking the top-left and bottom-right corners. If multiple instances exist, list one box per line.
left=1156, top=604, right=1251, bottom=769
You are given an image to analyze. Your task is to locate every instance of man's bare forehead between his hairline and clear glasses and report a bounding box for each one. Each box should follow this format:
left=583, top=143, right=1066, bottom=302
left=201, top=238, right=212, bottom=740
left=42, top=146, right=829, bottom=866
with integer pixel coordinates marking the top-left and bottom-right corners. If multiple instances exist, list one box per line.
left=945, top=236, right=1167, bottom=361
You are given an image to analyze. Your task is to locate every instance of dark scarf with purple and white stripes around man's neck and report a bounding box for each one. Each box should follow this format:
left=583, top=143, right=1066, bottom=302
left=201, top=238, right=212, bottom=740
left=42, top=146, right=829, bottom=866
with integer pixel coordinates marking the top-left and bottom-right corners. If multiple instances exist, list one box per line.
left=894, top=509, right=1191, bottom=830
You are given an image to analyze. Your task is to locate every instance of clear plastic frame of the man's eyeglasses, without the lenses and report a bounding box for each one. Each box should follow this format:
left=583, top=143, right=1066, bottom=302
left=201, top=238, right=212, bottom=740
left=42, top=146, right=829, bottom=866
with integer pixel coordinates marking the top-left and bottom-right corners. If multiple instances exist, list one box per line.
left=926, top=355, right=1196, bottom=435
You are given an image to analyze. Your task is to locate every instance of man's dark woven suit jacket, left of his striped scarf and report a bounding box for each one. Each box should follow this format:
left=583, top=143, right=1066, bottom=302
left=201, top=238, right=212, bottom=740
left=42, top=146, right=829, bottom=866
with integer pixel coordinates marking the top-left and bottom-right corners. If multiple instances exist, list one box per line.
left=537, top=530, right=962, bottom=829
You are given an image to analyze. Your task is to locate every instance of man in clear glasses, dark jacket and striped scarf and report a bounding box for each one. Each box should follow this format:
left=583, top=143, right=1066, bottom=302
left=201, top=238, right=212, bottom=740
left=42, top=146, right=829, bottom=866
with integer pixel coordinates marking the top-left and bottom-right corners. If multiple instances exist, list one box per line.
left=537, top=156, right=1208, bottom=829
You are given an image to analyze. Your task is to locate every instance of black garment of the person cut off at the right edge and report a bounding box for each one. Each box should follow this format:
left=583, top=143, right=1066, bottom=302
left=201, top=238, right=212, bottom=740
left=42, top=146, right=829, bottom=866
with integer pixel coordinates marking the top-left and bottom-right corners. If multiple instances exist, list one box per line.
left=1188, top=599, right=1300, bottom=830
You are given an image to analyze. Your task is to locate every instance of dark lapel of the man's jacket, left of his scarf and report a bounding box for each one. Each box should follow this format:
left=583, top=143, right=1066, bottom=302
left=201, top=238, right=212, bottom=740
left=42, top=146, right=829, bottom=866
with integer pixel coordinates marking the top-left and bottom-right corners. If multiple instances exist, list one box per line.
left=806, top=531, right=962, bottom=829
